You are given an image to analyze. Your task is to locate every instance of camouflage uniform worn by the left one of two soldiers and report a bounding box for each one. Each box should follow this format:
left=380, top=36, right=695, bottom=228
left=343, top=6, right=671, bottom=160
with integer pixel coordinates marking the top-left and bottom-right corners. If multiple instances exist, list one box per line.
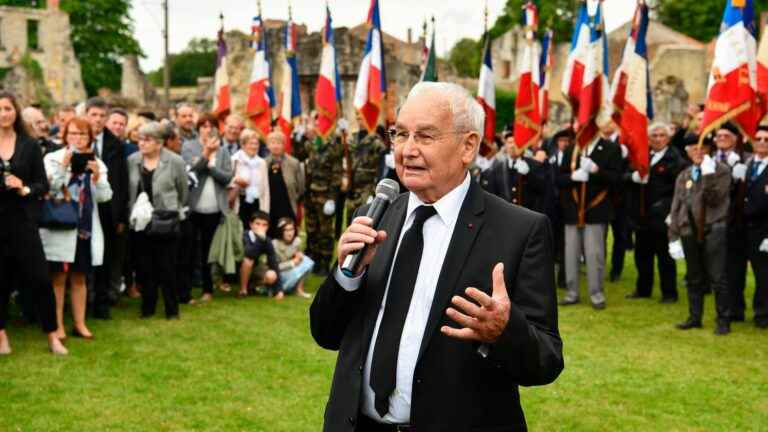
left=303, top=136, right=343, bottom=271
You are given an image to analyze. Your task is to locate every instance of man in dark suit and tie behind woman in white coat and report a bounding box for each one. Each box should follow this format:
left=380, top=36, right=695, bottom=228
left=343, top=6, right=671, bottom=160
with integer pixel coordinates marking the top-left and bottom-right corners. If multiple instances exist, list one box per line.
left=85, top=97, right=128, bottom=319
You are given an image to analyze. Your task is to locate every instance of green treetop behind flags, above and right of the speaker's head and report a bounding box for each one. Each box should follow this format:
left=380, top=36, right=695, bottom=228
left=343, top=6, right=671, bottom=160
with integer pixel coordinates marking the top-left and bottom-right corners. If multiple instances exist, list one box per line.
left=489, top=0, right=575, bottom=42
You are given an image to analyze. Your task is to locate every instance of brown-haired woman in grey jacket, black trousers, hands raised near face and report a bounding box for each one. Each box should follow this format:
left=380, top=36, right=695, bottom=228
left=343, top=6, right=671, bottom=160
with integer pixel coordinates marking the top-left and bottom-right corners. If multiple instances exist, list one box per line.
left=181, top=113, right=234, bottom=302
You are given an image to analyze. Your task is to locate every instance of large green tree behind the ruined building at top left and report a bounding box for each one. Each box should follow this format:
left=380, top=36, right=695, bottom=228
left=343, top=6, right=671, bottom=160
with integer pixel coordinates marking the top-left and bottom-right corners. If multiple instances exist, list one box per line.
left=61, top=0, right=143, bottom=95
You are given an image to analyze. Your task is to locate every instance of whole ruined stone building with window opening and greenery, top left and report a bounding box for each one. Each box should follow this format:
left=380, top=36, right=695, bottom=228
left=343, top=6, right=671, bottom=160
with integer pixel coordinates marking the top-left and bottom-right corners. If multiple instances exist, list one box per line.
left=0, top=0, right=86, bottom=104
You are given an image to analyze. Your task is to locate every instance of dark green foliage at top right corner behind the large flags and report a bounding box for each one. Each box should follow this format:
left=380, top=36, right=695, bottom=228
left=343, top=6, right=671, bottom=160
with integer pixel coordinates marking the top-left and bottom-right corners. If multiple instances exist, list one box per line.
left=657, top=0, right=768, bottom=42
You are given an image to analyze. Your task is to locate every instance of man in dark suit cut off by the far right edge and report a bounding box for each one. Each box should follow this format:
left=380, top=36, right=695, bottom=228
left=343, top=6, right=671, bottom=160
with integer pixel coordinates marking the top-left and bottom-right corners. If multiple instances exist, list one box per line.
left=731, top=126, right=768, bottom=329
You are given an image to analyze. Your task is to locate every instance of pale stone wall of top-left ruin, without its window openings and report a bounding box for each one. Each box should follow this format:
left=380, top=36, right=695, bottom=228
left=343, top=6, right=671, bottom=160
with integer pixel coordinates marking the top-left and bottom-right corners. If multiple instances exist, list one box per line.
left=0, top=1, right=86, bottom=104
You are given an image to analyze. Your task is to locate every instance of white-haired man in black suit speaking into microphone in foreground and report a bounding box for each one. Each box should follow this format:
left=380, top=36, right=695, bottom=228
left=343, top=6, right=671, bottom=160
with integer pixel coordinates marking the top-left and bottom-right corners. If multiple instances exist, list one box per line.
left=310, top=83, right=563, bottom=432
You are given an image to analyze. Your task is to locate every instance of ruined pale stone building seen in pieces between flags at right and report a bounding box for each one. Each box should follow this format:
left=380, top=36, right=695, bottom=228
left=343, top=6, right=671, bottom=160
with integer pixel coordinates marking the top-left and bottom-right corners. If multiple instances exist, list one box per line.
left=492, top=20, right=711, bottom=128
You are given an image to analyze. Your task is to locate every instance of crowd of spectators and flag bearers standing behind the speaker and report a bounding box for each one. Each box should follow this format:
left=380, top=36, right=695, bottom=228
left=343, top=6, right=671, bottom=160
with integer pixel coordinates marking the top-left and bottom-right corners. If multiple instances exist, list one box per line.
left=0, top=92, right=768, bottom=354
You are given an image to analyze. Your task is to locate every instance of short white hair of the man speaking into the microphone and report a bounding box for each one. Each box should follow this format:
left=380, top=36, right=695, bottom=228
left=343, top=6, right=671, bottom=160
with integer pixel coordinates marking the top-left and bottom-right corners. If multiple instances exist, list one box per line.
left=406, top=82, right=485, bottom=136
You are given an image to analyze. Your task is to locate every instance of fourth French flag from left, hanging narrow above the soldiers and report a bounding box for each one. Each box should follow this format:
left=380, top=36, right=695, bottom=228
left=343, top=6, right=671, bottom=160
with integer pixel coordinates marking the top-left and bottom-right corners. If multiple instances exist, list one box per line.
left=315, top=7, right=341, bottom=139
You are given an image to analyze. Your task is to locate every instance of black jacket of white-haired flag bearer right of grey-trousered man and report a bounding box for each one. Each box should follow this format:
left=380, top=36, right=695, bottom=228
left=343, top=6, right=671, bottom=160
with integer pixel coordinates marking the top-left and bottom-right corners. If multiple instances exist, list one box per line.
left=624, top=146, right=688, bottom=233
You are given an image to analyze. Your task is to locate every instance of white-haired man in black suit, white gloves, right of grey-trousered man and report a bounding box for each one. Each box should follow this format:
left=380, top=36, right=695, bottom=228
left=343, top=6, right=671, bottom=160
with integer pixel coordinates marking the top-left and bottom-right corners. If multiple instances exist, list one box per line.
left=625, top=123, right=687, bottom=303
